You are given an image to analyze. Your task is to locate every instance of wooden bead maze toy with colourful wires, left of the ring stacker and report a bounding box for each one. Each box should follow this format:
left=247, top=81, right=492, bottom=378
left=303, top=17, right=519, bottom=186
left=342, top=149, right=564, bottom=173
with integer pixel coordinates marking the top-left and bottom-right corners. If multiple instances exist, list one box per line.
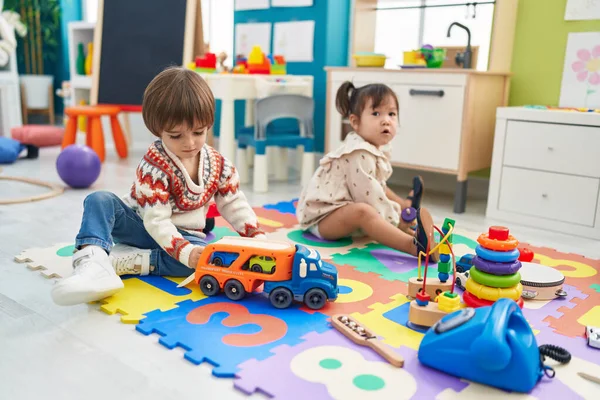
left=408, top=218, right=464, bottom=327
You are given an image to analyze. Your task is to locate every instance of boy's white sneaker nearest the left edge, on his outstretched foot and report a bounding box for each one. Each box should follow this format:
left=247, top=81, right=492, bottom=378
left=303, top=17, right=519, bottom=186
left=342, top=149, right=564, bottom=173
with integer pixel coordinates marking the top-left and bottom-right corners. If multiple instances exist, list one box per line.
left=52, top=246, right=124, bottom=306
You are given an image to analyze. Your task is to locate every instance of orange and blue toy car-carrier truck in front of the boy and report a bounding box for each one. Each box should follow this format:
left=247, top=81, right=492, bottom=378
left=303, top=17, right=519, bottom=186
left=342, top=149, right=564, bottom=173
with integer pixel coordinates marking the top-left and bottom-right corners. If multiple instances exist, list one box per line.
left=194, top=236, right=339, bottom=310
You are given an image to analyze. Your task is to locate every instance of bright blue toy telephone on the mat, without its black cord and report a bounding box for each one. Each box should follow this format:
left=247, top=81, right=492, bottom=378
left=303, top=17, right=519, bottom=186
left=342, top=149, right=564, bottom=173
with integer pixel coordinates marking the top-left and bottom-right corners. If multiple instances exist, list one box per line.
left=419, top=298, right=544, bottom=393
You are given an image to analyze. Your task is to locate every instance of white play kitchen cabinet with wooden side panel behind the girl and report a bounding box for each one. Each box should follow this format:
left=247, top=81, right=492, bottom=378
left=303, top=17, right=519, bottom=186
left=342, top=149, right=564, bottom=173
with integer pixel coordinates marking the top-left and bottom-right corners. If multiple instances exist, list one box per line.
left=325, top=67, right=510, bottom=213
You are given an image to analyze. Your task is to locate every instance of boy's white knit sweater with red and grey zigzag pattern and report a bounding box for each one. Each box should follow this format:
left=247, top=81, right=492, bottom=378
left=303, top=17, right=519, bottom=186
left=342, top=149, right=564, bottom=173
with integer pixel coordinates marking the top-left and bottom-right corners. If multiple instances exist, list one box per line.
left=124, top=140, right=264, bottom=266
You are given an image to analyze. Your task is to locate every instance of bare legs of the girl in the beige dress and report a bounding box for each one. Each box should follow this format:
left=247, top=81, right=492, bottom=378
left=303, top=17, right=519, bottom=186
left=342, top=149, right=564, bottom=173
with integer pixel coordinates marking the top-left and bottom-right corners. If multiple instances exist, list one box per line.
left=319, top=203, right=433, bottom=256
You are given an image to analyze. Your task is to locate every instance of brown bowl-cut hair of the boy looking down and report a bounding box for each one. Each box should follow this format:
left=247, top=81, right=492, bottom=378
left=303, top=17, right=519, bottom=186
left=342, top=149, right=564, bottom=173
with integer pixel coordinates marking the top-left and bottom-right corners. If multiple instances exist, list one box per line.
left=142, top=67, right=215, bottom=137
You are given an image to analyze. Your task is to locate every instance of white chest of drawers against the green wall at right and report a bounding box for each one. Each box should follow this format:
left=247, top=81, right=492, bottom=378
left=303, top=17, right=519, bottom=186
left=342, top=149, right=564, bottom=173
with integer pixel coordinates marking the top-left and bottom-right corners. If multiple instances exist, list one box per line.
left=486, top=107, right=600, bottom=239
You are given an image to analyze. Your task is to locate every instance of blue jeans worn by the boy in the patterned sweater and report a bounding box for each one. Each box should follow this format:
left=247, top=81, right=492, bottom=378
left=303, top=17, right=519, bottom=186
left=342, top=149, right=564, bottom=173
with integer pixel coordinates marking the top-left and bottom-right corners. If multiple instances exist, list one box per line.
left=75, top=191, right=206, bottom=277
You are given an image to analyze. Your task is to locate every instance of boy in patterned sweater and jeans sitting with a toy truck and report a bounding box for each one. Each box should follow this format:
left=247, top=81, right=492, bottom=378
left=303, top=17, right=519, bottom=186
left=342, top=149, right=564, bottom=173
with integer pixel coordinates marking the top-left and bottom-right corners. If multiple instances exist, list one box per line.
left=52, top=68, right=264, bottom=305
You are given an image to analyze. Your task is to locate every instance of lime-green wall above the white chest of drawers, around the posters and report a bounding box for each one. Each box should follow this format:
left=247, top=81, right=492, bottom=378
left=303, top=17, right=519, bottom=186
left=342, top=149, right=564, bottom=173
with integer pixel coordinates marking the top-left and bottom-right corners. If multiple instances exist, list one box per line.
left=509, top=0, right=600, bottom=106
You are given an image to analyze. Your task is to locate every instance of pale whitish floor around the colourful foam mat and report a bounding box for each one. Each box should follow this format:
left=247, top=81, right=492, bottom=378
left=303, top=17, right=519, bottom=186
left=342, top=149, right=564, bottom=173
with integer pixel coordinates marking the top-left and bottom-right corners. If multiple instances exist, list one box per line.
left=0, top=143, right=600, bottom=400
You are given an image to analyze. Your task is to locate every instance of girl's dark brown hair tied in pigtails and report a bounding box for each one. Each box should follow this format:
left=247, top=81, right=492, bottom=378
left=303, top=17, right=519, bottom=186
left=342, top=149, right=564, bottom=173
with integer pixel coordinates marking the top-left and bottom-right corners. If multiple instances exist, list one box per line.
left=335, top=81, right=399, bottom=118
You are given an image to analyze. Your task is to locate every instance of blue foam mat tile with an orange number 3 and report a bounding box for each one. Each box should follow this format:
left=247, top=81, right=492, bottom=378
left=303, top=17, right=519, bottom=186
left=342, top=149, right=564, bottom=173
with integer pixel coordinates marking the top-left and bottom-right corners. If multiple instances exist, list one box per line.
left=136, top=294, right=331, bottom=377
